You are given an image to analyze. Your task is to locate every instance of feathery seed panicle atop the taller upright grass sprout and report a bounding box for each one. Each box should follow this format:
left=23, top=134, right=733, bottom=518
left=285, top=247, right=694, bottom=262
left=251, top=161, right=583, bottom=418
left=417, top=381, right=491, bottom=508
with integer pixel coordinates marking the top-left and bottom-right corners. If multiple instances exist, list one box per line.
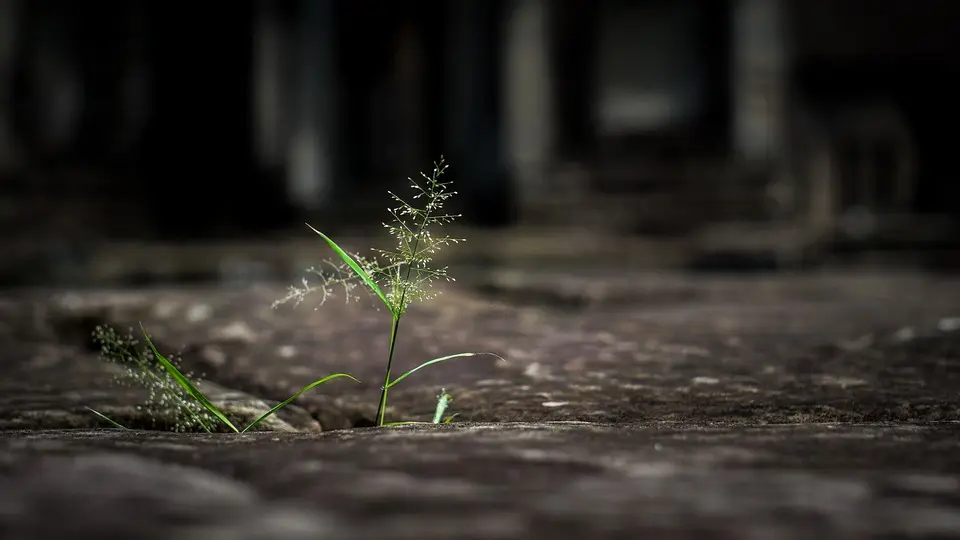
left=273, top=158, right=463, bottom=313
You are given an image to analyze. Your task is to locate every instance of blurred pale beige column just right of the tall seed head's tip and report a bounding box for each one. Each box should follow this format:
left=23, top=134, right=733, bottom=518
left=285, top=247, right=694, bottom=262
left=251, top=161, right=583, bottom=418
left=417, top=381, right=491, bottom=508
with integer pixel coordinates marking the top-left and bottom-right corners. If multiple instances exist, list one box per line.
left=503, top=0, right=554, bottom=219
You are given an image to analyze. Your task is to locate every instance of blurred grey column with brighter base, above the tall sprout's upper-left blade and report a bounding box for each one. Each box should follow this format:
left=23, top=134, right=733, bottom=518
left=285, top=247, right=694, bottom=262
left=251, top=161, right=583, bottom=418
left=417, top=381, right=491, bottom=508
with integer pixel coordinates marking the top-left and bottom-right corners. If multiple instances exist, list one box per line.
left=287, top=0, right=337, bottom=210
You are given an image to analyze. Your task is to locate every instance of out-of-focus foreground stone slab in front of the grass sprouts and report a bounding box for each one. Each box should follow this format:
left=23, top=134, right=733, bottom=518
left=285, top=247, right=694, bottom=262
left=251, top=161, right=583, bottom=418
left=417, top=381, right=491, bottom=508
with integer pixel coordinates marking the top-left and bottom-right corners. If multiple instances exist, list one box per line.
left=0, top=422, right=960, bottom=540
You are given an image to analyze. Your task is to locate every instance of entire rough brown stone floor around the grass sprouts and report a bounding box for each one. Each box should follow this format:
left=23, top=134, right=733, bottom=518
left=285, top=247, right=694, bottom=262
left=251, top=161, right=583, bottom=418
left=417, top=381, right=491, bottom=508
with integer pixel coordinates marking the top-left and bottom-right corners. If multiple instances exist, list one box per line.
left=0, top=271, right=960, bottom=539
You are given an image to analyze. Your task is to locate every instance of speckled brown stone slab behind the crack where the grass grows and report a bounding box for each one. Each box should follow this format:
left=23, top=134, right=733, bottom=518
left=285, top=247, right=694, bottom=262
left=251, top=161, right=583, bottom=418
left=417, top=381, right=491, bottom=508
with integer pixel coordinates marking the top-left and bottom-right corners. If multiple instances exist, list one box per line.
left=0, top=274, right=960, bottom=429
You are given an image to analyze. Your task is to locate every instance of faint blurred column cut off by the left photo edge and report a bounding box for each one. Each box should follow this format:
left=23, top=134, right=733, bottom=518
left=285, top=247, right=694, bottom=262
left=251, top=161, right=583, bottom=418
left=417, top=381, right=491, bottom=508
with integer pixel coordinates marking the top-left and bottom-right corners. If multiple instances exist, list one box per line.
left=0, top=0, right=20, bottom=172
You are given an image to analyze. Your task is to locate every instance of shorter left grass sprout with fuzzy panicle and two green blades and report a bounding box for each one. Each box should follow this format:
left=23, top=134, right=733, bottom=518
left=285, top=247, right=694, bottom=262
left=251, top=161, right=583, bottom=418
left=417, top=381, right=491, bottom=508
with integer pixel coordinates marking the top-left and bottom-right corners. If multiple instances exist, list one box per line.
left=87, top=325, right=360, bottom=433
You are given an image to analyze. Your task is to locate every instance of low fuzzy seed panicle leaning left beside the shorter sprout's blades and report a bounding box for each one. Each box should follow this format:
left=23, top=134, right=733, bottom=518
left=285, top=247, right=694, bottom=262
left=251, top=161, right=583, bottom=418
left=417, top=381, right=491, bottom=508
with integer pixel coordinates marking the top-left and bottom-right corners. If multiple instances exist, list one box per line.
left=93, top=325, right=217, bottom=432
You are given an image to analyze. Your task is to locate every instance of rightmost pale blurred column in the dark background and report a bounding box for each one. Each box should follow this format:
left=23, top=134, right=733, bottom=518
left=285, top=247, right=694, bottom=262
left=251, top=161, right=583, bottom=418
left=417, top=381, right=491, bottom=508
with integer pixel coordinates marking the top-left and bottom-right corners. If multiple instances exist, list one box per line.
left=731, top=0, right=788, bottom=161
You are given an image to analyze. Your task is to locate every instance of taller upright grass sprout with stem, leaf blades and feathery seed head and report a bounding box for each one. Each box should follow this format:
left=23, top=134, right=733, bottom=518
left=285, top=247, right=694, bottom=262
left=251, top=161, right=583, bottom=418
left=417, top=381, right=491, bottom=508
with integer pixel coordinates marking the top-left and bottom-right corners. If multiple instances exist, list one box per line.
left=274, top=158, right=503, bottom=426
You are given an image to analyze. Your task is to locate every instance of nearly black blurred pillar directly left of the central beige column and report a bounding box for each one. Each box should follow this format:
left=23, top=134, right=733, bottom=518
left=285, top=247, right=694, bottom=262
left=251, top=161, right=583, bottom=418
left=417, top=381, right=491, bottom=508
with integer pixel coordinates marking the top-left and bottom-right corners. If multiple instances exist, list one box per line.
left=450, top=0, right=515, bottom=226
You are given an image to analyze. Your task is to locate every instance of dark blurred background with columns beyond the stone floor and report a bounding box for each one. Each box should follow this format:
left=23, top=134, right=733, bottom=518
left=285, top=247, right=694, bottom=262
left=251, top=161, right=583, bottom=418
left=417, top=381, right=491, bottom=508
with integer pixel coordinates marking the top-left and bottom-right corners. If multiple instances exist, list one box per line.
left=0, top=0, right=960, bottom=285
